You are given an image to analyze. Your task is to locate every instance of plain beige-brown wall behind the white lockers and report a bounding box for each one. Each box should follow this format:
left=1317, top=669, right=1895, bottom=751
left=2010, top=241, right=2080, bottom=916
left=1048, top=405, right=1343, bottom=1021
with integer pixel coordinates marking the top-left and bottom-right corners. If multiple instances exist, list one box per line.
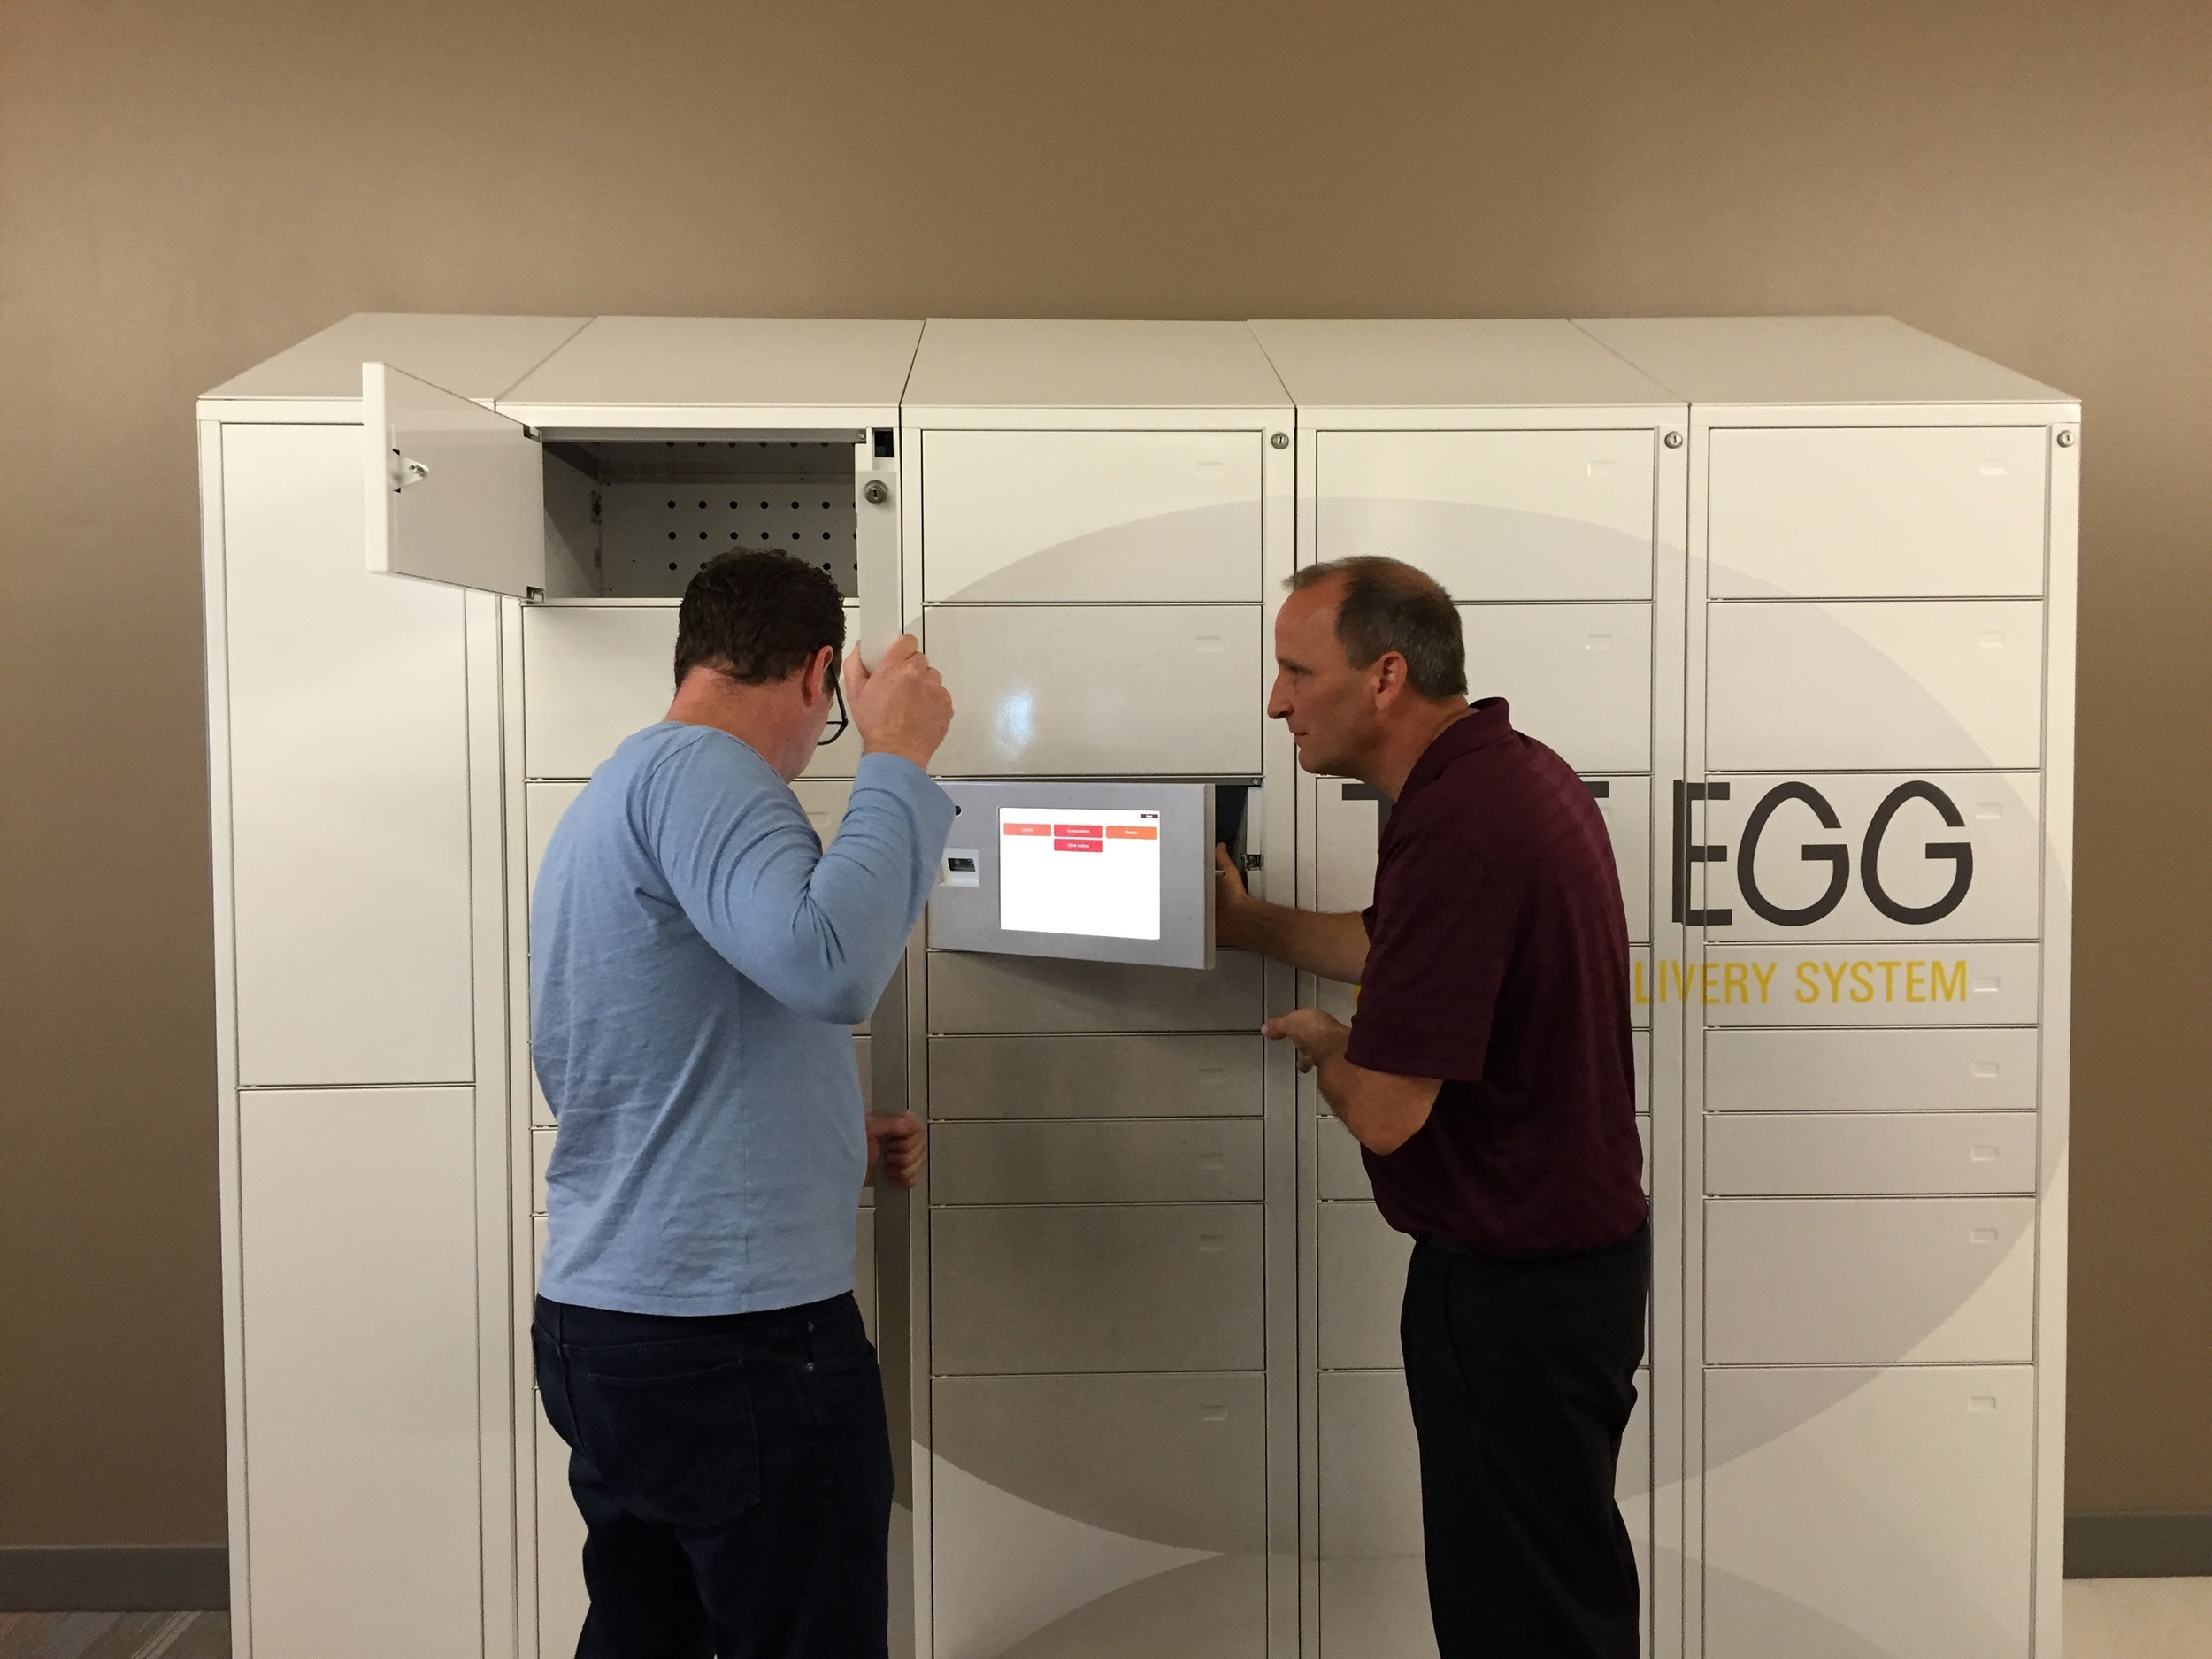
left=0, top=0, right=2212, bottom=1544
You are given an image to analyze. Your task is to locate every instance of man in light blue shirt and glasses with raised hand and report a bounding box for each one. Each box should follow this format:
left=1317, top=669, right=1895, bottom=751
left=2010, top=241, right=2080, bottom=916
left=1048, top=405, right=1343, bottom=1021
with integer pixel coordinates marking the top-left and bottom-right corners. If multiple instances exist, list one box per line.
left=531, top=553, right=954, bottom=1659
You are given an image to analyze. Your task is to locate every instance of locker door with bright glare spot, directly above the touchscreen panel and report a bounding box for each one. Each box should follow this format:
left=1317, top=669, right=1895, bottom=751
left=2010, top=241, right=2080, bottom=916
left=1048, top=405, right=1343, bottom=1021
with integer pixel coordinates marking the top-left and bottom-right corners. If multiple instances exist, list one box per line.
left=925, top=604, right=1268, bottom=779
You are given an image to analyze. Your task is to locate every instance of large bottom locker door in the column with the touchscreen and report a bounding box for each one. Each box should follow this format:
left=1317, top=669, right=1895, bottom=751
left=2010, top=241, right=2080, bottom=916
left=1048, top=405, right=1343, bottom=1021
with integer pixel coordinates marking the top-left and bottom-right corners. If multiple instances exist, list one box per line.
left=932, top=1371, right=1268, bottom=1659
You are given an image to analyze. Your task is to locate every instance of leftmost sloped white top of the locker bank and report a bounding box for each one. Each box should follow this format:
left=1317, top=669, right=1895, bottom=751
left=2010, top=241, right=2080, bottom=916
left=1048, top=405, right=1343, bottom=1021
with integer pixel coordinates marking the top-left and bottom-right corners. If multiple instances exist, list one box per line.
left=204, top=312, right=591, bottom=403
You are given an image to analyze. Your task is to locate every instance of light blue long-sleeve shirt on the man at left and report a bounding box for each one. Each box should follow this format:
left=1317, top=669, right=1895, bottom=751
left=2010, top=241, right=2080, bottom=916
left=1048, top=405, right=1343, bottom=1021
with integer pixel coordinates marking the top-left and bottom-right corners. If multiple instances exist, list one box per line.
left=531, top=721, right=954, bottom=1314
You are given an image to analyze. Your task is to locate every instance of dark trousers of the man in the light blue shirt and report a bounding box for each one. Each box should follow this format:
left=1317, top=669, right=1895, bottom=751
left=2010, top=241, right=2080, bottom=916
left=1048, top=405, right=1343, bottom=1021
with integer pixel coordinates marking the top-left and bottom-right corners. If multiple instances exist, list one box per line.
left=531, top=1296, right=892, bottom=1659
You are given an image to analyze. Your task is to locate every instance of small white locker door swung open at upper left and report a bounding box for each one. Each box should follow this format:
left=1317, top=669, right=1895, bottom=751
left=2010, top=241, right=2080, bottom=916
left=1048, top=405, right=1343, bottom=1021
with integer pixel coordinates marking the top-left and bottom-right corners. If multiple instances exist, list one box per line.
left=361, top=363, right=547, bottom=600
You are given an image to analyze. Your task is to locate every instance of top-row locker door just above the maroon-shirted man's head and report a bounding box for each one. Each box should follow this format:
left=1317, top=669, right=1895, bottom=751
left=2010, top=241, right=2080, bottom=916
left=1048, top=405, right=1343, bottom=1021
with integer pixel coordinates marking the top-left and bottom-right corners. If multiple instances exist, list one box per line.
left=1314, top=432, right=1653, bottom=600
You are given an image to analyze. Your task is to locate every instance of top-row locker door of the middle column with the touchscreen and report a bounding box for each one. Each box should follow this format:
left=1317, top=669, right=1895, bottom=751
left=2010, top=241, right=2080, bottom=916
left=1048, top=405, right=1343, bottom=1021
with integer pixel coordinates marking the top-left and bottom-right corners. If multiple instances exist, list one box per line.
left=923, top=432, right=1263, bottom=606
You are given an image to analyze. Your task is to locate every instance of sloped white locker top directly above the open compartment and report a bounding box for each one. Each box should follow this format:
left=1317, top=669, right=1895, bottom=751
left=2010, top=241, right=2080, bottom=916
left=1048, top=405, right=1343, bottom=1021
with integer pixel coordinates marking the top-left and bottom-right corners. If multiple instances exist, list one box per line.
left=500, top=317, right=923, bottom=420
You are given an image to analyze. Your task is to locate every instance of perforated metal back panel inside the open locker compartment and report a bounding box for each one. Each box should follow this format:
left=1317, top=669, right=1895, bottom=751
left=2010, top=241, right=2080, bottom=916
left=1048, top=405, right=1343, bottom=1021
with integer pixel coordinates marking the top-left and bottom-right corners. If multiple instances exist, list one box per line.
left=562, top=441, right=861, bottom=600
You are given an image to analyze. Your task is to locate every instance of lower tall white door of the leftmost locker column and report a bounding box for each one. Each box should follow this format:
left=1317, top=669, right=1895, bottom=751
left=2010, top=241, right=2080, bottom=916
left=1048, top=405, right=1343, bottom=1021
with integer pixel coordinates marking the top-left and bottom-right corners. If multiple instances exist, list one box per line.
left=237, top=1088, right=487, bottom=1659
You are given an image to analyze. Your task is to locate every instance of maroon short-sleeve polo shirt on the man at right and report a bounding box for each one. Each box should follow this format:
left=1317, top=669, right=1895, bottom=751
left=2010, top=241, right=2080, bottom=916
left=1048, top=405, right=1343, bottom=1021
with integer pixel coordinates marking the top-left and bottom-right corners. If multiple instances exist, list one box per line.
left=1345, top=697, right=1648, bottom=1256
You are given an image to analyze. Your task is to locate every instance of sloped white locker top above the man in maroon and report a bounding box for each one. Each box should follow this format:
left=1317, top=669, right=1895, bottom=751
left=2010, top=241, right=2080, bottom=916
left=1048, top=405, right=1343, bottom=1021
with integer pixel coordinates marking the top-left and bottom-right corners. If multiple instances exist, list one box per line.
left=1252, top=319, right=1681, bottom=410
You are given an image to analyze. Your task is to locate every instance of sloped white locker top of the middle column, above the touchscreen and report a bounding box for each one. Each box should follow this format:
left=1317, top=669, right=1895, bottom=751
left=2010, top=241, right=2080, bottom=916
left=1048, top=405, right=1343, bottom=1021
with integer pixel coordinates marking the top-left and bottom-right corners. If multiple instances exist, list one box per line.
left=907, top=317, right=1290, bottom=411
